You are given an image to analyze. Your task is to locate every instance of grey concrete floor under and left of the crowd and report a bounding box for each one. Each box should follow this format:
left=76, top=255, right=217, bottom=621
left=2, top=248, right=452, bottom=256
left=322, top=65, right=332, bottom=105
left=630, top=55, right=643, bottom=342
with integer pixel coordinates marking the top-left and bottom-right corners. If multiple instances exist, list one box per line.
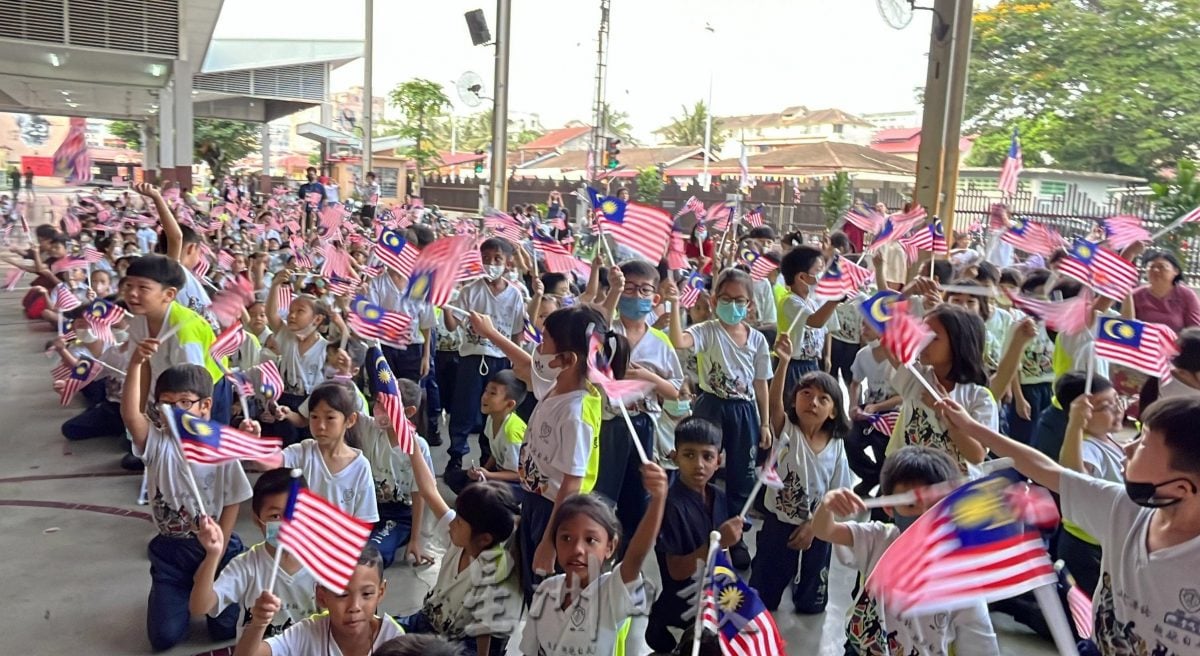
left=0, top=214, right=1055, bottom=656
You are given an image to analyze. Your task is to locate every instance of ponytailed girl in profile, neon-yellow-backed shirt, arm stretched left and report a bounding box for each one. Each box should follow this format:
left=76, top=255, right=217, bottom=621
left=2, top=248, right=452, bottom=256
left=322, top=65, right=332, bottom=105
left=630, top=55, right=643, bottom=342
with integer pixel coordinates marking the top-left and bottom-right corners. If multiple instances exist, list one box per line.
left=470, top=306, right=609, bottom=601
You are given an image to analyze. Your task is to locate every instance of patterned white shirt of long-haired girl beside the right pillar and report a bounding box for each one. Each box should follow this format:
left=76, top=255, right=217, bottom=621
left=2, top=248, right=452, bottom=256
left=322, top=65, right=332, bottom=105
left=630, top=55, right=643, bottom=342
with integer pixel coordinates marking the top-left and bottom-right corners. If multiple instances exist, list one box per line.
left=886, top=368, right=1000, bottom=474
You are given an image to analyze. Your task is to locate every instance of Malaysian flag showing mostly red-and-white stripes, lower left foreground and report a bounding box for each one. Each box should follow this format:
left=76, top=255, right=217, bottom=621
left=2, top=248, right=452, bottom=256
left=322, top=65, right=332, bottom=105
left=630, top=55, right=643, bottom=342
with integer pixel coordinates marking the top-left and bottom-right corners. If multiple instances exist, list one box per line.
left=280, top=480, right=372, bottom=595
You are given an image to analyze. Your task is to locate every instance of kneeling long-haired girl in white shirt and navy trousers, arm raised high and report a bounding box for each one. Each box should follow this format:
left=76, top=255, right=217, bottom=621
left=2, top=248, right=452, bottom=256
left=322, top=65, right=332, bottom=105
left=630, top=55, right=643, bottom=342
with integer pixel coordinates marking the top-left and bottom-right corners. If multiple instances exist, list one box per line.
left=750, top=335, right=853, bottom=614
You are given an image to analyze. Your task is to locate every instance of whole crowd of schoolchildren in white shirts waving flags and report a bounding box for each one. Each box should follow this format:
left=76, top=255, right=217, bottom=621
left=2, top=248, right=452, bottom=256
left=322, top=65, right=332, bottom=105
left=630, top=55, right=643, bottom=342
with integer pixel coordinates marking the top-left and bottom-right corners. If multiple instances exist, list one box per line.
left=10, top=183, right=1200, bottom=656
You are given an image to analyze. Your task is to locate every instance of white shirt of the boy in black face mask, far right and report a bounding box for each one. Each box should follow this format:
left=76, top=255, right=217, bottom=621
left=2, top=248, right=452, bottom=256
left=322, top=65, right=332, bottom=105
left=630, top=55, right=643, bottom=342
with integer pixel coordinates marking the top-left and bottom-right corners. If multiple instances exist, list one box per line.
left=1058, top=470, right=1200, bottom=656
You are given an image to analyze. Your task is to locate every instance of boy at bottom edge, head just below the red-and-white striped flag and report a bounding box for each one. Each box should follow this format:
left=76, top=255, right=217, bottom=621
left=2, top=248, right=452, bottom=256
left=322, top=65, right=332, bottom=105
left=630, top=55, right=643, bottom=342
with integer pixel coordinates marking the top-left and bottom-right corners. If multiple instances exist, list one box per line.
left=234, top=543, right=404, bottom=656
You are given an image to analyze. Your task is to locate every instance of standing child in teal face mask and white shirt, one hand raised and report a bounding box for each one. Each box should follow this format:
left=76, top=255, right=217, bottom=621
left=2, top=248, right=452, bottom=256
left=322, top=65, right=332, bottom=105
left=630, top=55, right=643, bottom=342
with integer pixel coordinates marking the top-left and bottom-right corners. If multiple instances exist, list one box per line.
left=666, top=269, right=772, bottom=568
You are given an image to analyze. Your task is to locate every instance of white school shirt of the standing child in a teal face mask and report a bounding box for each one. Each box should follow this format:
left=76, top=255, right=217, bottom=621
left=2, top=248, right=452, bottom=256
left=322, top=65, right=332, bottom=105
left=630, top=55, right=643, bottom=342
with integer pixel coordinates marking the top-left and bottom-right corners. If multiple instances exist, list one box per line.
left=688, top=319, right=773, bottom=401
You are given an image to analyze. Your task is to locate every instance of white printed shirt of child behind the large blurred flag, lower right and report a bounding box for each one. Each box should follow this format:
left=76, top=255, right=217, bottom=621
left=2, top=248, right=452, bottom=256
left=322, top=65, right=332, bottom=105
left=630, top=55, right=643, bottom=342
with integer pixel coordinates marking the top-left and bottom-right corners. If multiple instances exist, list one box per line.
left=834, top=522, right=1000, bottom=656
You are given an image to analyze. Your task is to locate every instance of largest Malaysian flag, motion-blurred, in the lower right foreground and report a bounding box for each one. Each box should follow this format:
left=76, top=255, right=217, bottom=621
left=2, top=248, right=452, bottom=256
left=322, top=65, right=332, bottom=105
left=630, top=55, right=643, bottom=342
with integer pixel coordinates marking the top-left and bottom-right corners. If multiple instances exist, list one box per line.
left=866, top=470, right=1057, bottom=618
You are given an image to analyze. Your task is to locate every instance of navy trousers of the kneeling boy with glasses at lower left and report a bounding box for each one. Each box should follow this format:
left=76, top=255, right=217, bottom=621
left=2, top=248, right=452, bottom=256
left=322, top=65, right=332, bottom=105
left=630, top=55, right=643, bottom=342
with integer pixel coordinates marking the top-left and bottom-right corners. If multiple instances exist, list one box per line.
left=146, top=534, right=244, bottom=651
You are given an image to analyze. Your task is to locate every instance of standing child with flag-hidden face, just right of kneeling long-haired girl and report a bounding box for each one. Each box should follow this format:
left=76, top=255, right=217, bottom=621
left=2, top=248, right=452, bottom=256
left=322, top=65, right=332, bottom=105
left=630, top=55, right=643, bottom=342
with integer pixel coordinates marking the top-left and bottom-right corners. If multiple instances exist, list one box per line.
left=846, top=319, right=901, bottom=496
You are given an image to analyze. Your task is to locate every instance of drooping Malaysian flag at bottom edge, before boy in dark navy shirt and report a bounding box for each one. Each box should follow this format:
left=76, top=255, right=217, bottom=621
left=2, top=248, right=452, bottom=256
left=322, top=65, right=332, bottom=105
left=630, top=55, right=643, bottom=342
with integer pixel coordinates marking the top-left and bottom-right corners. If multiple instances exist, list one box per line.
left=702, top=550, right=787, bottom=656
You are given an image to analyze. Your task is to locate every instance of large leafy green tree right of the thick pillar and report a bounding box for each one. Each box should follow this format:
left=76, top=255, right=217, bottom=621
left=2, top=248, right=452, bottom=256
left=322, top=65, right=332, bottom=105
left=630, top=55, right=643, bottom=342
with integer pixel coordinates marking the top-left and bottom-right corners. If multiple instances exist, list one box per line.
left=965, top=0, right=1200, bottom=175
